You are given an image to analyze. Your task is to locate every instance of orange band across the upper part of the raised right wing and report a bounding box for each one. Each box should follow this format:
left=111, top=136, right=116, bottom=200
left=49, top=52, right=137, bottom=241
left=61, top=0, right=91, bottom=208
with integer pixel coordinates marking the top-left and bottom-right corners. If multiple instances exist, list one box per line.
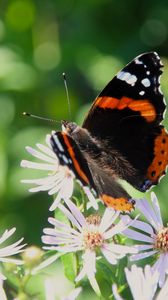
left=95, top=96, right=156, bottom=122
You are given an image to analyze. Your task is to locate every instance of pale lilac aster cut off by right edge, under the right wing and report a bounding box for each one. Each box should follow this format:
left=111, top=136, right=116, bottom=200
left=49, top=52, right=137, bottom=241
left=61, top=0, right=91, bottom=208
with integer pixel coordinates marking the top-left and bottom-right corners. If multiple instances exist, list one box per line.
left=123, top=193, right=168, bottom=287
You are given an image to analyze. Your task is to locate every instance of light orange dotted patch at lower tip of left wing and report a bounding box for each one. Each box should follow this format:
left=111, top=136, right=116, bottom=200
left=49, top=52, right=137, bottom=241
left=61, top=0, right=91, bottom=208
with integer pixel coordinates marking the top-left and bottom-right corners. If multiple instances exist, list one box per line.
left=101, top=194, right=134, bottom=211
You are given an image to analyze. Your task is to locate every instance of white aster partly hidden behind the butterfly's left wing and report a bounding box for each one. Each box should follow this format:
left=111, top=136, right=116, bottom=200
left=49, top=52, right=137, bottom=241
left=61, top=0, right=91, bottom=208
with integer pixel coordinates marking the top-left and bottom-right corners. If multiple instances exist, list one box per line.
left=21, top=134, right=98, bottom=211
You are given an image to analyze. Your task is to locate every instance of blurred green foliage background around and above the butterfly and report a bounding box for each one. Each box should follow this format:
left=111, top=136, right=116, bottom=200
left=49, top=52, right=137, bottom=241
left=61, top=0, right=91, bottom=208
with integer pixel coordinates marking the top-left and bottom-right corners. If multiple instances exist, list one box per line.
left=0, top=0, right=168, bottom=298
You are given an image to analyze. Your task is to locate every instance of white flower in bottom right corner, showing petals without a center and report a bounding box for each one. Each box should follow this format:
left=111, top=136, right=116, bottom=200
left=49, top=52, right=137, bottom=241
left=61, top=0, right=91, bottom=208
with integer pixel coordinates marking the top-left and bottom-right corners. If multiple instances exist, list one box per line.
left=112, top=265, right=168, bottom=300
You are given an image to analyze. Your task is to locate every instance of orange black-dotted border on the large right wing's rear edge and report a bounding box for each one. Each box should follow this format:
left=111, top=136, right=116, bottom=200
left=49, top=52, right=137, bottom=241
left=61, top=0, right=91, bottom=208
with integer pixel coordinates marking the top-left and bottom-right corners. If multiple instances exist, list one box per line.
left=147, top=128, right=168, bottom=183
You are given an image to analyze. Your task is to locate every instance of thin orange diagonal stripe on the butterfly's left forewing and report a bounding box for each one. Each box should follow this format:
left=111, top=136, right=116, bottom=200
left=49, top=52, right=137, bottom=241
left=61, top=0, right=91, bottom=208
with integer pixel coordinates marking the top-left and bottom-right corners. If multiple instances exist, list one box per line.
left=62, top=133, right=89, bottom=184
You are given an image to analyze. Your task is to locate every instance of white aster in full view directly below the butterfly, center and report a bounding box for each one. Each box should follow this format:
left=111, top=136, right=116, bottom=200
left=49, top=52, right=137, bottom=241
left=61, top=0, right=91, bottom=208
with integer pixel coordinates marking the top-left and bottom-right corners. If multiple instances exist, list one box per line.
left=39, top=200, right=137, bottom=294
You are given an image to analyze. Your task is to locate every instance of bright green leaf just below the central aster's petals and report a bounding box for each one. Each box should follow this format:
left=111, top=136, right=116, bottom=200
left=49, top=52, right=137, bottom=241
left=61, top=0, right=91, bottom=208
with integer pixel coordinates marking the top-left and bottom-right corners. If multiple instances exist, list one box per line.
left=61, top=253, right=77, bottom=282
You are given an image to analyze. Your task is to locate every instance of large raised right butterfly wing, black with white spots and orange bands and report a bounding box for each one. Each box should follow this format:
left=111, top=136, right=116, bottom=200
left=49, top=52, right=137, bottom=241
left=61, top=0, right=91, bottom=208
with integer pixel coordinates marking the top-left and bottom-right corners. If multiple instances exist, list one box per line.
left=83, top=52, right=168, bottom=191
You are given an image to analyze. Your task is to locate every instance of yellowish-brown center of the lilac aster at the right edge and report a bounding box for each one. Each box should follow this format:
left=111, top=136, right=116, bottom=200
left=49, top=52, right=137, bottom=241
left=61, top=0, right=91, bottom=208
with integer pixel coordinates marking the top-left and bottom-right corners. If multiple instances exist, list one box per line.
left=154, top=227, right=168, bottom=252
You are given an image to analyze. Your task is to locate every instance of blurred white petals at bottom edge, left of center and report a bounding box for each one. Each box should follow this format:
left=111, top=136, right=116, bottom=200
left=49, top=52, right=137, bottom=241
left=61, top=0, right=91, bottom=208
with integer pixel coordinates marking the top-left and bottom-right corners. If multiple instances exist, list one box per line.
left=44, top=278, right=82, bottom=300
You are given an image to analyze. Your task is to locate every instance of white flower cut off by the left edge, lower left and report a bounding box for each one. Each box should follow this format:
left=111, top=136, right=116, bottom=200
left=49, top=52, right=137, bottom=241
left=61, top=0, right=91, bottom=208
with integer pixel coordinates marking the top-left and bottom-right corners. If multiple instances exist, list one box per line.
left=0, top=228, right=26, bottom=280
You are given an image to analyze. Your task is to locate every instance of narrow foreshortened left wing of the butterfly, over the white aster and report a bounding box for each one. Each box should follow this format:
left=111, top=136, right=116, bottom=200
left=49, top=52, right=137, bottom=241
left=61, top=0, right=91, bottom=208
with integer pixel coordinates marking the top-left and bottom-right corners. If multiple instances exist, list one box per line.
left=50, top=132, right=134, bottom=211
